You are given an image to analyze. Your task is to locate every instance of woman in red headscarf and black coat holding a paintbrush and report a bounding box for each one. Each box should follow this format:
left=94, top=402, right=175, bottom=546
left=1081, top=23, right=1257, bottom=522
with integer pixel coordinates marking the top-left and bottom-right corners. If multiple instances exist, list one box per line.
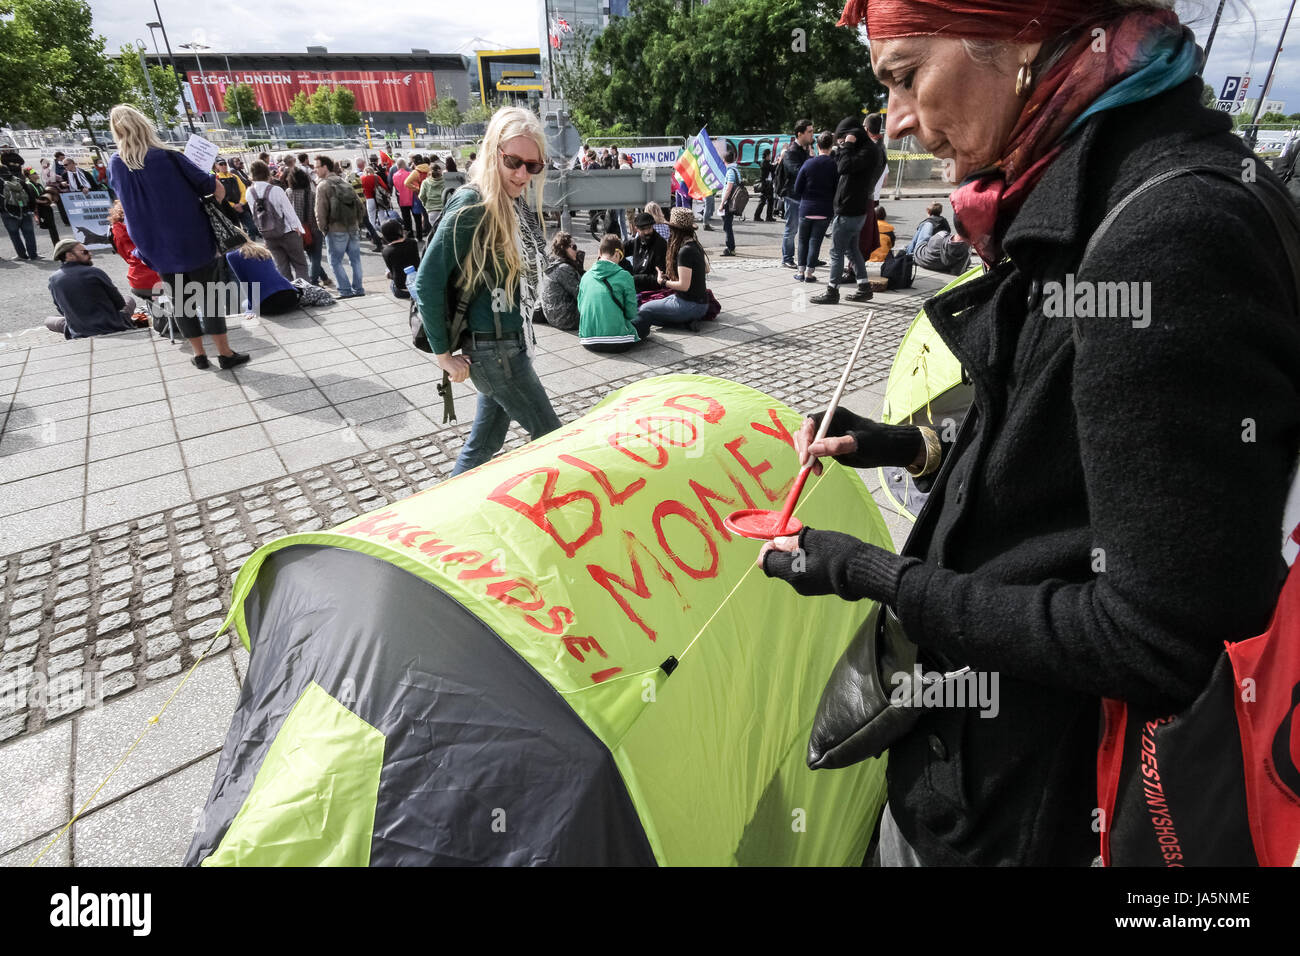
left=758, top=0, right=1300, bottom=865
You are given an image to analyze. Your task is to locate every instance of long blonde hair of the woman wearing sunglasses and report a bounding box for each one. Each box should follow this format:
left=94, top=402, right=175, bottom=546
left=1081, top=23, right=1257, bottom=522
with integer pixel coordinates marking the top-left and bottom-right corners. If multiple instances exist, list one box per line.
left=451, top=107, right=546, bottom=307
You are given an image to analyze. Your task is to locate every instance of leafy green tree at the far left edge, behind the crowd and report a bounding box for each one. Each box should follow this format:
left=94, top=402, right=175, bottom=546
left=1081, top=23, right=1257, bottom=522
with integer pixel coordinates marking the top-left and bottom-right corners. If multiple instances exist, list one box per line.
left=0, top=0, right=124, bottom=148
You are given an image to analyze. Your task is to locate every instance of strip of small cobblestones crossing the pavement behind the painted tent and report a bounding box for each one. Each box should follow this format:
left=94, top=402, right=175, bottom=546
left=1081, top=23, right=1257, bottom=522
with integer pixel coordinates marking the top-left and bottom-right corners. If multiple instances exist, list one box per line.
left=0, top=297, right=920, bottom=741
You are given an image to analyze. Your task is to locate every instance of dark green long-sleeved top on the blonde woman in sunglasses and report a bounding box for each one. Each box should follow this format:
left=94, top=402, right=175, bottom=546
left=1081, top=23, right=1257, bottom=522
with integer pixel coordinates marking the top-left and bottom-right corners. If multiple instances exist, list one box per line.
left=415, top=186, right=524, bottom=355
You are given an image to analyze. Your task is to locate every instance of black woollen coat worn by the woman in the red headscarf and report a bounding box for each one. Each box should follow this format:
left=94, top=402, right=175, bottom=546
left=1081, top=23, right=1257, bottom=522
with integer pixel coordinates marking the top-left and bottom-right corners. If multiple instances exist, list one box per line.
left=821, top=78, right=1300, bottom=865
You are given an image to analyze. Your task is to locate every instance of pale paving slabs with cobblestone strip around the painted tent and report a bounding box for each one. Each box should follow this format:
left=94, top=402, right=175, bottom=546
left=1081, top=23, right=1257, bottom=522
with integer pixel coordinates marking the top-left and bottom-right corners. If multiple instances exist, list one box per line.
left=0, top=243, right=944, bottom=865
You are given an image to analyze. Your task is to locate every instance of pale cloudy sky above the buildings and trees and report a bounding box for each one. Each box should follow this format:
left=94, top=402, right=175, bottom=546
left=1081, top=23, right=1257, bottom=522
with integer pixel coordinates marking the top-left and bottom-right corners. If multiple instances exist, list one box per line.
left=90, top=0, right=1300, bottom=113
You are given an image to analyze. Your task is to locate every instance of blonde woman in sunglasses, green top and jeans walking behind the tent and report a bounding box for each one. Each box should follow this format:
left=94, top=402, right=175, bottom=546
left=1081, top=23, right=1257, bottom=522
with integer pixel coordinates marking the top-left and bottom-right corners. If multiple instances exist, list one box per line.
left=415, top=107, right=560, bottom=477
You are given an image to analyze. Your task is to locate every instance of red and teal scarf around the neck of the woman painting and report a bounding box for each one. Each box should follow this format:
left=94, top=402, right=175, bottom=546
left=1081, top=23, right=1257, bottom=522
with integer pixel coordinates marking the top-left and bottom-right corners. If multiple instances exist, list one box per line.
left=952, top=10, right=1201, bottom=265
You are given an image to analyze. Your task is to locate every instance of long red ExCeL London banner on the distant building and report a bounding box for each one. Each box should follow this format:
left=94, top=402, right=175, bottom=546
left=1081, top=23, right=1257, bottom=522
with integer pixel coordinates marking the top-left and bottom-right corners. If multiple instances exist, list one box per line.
left=187, top=70, right=437, bottom=113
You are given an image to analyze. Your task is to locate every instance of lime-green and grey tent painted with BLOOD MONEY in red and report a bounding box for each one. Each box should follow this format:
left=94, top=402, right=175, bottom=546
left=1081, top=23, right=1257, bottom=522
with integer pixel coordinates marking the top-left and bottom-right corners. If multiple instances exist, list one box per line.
left=186, top=375, right=891, bottom=865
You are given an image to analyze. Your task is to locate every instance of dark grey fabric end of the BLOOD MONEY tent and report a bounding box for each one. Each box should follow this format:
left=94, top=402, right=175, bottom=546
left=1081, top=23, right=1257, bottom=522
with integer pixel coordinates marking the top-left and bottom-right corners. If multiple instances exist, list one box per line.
left=185, top=545, right=655, bottom=865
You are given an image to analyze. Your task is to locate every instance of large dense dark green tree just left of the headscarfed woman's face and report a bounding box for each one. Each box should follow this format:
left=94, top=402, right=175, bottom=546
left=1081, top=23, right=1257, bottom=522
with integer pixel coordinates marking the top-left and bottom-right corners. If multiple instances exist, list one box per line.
left=582, top=0, right=884, bottom=135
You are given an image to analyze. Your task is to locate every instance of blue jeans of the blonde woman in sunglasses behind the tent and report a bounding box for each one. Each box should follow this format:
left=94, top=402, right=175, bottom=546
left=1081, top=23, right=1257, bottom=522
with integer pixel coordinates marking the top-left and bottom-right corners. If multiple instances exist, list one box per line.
left=451, top=338, right=560, bottom=477
